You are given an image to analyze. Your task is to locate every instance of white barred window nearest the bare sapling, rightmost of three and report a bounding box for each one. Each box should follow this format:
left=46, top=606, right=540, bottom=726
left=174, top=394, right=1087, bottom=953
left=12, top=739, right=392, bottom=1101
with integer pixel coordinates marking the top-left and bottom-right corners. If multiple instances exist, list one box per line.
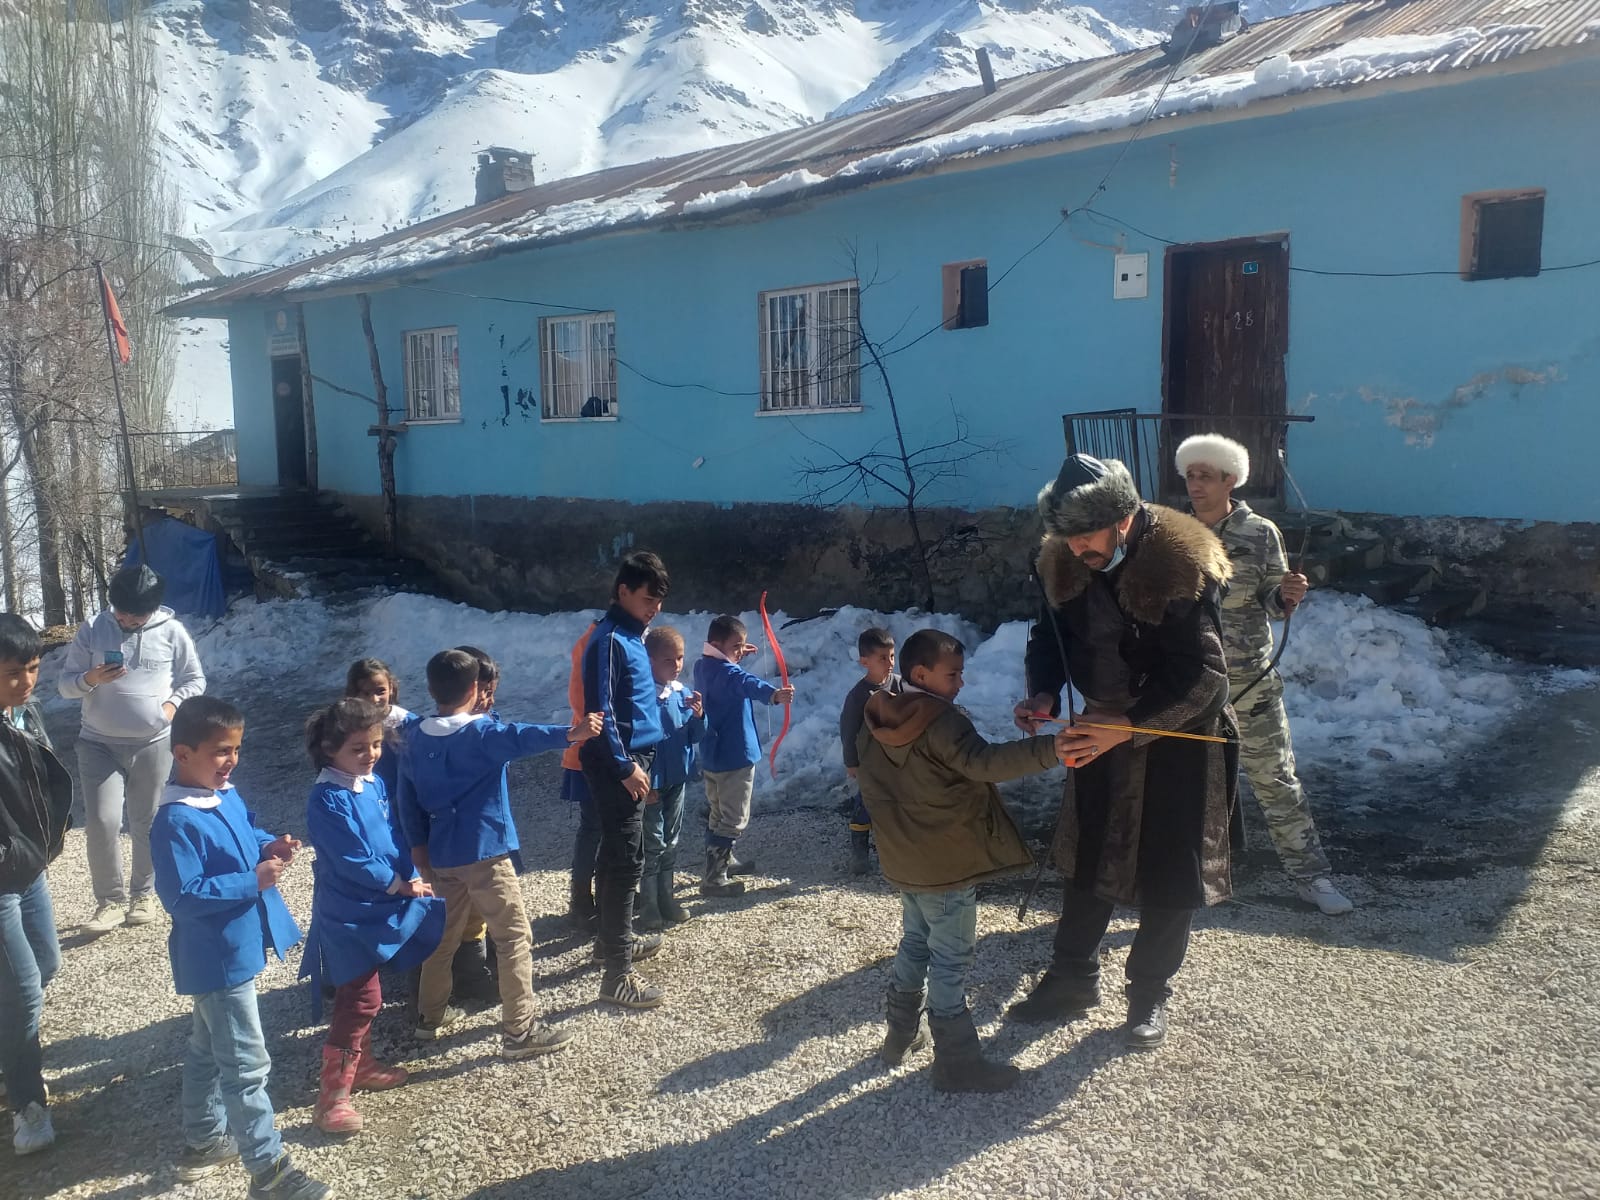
left=757, top=278, right=861, bottom=416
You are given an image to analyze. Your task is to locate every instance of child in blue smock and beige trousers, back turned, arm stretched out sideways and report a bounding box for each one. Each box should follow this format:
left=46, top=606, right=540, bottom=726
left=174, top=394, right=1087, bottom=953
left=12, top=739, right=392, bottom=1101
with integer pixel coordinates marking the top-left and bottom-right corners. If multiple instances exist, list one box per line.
left=400, top=650, right=600, bottom=1061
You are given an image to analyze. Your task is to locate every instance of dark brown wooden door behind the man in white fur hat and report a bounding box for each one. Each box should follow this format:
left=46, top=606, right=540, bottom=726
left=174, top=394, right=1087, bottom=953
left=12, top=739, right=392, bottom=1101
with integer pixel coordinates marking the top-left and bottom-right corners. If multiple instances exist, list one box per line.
left=1162, top=237, right=1290, bottom=496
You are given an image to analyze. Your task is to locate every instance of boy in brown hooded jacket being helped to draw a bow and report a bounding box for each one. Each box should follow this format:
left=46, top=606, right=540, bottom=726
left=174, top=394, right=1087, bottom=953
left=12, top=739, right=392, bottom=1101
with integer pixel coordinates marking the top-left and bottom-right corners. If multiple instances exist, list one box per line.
left=856, top=629, right=1059, bottom=1091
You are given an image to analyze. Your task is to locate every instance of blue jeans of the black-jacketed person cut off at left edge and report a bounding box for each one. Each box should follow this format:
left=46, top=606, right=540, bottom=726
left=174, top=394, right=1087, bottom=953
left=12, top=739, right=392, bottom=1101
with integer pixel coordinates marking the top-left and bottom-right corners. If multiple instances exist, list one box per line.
left=0, top=872, right=61, bottom=1112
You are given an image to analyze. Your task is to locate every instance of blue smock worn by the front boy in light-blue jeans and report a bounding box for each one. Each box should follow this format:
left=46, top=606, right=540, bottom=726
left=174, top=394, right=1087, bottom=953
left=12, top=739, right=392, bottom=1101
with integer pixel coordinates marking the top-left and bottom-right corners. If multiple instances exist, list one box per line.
left=150, top=784, right=301, bottom=995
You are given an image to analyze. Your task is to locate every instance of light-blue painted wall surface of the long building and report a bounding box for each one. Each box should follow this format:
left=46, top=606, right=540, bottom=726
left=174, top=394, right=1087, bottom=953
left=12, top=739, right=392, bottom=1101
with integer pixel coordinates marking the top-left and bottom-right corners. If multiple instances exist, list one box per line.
left=232, top=62, right=1600, bottom=520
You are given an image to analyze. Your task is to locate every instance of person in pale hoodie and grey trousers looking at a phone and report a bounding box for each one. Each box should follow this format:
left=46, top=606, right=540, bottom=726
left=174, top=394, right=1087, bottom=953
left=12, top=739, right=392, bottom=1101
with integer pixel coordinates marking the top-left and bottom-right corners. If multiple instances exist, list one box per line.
left=59, top=565, right=205, bottom=933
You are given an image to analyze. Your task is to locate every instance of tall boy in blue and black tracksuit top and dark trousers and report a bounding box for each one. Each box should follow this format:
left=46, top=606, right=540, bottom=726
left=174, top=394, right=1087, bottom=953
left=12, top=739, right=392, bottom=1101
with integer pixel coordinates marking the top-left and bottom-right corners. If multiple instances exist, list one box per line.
left=579, top=550, right=670, bottom=1008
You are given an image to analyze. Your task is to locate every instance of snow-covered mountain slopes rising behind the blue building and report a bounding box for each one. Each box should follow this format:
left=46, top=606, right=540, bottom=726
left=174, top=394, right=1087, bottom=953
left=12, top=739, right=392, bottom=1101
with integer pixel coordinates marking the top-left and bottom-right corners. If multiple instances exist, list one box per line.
left=150, top=0, right=1318, bottom=422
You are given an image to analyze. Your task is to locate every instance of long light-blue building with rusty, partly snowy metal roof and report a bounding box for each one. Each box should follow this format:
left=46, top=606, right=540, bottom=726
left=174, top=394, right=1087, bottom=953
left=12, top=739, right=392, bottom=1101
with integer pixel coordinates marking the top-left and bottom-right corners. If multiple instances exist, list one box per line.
left=179, top=0, right=1600, bottom=611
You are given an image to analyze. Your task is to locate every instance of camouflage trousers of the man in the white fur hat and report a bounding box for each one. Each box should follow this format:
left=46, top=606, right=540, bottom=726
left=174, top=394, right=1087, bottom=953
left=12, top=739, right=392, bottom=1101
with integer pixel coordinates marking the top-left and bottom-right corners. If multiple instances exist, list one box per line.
left=1229, top=670, right=1330, bottom=880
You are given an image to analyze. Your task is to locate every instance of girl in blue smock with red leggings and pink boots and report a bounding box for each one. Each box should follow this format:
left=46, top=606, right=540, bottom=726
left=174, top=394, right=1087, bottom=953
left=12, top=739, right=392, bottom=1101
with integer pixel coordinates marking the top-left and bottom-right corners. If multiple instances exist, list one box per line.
left=301, top=699, right=445, bottom=1133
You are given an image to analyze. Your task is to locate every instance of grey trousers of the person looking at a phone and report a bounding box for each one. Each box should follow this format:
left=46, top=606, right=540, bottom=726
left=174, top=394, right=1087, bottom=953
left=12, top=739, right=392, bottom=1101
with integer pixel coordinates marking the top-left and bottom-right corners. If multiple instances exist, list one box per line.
left=78, top=738, right=173, bottom=904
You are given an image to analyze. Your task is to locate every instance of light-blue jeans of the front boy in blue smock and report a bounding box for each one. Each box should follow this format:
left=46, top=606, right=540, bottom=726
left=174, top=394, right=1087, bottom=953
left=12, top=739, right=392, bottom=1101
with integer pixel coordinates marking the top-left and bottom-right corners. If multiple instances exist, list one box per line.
left=182, top=979, right=283, bottom=1174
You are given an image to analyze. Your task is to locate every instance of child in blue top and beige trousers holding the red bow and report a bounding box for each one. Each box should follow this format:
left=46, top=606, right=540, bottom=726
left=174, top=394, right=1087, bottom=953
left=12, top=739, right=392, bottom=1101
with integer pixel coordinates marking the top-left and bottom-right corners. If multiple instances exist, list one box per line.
left=694, top=616, right=795, bottom=896
